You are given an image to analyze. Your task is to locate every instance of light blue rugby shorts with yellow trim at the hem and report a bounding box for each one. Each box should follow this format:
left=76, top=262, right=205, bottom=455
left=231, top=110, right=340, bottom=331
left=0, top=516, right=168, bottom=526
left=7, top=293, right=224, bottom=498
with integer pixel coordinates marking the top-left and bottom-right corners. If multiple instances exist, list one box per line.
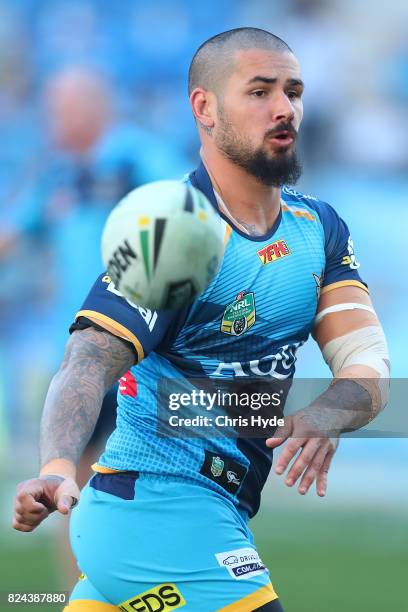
left=67, top=472, right=281, bottom=612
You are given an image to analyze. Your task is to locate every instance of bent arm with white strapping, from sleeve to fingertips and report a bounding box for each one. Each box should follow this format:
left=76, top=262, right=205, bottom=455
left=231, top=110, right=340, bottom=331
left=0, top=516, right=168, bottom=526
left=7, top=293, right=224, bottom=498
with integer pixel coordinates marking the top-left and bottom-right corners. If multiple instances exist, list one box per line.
left=267, top=286, right=389, bottom=496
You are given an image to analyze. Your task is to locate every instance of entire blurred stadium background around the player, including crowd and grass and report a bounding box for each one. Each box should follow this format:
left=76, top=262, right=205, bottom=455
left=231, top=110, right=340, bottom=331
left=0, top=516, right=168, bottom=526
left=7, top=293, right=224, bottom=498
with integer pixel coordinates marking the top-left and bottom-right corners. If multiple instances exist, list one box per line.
left=0, top=0, right=408, bottom=612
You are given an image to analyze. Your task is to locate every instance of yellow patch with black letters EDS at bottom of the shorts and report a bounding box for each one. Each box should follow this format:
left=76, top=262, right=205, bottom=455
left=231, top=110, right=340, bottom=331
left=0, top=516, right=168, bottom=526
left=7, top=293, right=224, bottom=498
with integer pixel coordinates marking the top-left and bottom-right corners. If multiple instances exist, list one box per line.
left=118, top=582, right=186, bottom=612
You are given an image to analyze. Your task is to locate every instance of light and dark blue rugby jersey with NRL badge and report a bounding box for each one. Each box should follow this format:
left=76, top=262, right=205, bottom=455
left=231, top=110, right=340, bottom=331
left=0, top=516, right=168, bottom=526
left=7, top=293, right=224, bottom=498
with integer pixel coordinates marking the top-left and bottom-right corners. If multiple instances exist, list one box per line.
left=73, top=165, right=366, bottom=516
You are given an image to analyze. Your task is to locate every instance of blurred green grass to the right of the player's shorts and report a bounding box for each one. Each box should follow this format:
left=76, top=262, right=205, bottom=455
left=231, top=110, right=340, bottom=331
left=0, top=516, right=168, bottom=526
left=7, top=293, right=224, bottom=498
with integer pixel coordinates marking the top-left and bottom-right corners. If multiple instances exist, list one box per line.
left=253, top=509, right=408, bottom=612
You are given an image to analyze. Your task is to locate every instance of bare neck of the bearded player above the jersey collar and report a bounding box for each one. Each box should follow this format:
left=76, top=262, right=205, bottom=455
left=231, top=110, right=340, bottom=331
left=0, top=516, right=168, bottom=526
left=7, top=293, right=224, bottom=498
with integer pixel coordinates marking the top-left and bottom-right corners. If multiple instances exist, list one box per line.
left=200, top=147, right=281, bottom=236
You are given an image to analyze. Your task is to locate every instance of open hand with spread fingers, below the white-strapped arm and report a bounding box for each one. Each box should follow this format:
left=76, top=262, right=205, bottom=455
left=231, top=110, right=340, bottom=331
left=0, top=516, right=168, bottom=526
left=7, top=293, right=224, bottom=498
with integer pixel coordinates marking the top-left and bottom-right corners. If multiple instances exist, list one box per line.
left=266, top=410, right=339, bottom=497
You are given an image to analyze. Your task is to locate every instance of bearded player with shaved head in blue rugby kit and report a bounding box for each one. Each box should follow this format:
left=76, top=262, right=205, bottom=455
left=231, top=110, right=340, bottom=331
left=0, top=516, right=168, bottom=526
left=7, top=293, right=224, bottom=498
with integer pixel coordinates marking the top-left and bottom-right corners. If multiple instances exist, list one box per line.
left=14, top=28, right=388, bottom=612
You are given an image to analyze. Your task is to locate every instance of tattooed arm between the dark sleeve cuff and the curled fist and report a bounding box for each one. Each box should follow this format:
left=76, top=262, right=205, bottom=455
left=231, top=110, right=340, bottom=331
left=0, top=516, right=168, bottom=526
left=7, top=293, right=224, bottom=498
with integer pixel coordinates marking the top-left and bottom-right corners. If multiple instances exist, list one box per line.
left=40, top=327, right=135, bottom=465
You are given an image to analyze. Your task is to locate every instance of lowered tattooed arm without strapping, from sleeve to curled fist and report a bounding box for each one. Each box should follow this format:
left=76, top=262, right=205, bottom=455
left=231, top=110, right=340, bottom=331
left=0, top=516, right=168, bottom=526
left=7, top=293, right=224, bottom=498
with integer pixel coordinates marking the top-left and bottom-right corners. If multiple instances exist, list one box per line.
left=13, top=327, right=135, bottom=531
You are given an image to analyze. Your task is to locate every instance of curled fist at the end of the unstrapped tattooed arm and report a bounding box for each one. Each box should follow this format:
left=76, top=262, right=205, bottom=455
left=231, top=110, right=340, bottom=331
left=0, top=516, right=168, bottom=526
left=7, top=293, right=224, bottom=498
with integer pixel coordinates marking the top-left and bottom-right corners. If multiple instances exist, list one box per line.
left=13, top=475, right=80, bottom=531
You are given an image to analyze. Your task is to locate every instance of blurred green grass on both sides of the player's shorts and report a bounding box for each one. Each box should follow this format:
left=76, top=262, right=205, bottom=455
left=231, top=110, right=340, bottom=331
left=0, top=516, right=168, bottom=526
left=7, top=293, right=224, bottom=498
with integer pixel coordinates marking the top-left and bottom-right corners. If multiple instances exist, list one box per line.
left=0, top=504, right=408, bottom=612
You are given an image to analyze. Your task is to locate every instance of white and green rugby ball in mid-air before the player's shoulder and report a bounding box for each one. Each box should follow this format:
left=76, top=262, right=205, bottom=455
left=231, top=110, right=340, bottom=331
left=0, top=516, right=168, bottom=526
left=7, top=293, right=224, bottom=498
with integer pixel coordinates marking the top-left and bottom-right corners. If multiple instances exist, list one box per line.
left=102, top=181, right=224, bottom=310
